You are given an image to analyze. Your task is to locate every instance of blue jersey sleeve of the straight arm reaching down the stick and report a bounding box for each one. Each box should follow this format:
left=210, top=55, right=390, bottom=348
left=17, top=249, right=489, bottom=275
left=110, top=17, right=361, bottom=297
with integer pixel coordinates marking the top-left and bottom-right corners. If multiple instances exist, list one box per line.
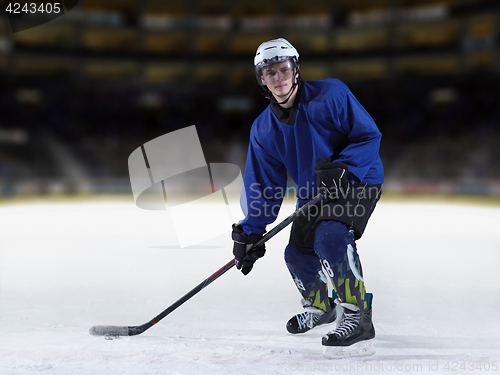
left=240, top=129, right=287, bottom=234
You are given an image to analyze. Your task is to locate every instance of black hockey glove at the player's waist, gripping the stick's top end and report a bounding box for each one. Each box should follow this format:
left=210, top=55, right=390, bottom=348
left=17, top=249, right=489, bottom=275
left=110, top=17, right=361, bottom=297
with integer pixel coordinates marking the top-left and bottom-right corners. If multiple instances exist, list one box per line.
left=314, top=159, right=349, bottom=198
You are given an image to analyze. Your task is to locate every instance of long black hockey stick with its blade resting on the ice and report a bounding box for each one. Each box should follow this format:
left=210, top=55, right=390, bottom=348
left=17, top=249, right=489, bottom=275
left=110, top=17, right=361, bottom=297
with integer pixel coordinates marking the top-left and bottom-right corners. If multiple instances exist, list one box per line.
left=90, top=190, right=325, bottom=336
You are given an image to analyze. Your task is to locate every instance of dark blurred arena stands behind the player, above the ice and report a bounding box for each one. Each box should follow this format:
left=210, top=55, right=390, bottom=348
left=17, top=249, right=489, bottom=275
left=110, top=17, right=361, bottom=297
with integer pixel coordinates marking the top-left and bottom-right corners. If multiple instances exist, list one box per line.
left=0, top=0, right=500, bottom=197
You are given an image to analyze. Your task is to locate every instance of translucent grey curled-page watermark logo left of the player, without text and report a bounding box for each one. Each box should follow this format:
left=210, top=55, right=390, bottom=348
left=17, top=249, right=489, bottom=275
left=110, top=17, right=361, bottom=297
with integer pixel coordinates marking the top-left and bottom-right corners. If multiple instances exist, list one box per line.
left=128, top=125, right=244, bottom=248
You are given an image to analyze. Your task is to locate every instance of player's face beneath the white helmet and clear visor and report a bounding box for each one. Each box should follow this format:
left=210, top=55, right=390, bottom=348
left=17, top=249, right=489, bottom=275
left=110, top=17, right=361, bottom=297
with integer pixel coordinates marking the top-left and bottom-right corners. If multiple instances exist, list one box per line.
left=261, top=61, right=295, bottom=101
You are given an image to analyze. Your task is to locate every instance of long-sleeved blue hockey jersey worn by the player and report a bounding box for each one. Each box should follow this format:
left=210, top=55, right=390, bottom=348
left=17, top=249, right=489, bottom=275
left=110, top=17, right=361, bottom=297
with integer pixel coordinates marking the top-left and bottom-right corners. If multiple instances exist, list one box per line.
left=240, top=79, right=384, bottom=234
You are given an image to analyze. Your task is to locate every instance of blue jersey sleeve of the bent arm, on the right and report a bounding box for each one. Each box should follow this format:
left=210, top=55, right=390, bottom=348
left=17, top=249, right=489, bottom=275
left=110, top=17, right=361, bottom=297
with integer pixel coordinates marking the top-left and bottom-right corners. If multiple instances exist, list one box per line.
left=336, top=83, right=382, bottom=181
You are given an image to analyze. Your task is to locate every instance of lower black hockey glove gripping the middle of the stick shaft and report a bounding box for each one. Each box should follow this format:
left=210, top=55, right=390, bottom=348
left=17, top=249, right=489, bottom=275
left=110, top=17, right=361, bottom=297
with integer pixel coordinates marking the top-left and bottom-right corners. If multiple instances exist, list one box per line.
left=232, top=224, right=266, bottom=275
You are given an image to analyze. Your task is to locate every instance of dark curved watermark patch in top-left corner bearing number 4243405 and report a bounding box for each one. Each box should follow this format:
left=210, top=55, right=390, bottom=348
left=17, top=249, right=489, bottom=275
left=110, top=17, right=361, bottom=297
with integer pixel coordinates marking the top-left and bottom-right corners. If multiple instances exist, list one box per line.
left=3, top=0, right=79, bottom=33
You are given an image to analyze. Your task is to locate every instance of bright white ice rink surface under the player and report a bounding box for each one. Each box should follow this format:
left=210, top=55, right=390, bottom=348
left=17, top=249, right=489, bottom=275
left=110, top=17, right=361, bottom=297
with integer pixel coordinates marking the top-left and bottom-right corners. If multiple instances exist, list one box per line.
left=0, top=201, right=500, bottom=375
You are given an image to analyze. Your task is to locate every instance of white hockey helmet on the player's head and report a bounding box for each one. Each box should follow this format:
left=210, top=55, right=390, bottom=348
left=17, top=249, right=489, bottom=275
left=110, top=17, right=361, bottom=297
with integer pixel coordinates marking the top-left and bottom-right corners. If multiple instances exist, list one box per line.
left=253, top=38, right=299, bottom=86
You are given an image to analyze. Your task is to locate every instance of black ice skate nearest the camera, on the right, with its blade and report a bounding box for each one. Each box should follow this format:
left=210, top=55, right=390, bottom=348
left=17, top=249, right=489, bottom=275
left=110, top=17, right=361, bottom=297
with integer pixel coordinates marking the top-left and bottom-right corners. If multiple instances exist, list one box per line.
left=322, top=303, right=375, bottom=359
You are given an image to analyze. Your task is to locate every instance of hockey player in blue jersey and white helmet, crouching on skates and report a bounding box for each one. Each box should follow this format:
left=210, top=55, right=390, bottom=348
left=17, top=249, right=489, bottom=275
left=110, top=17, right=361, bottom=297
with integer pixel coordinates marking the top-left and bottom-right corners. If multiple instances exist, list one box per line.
left=232, top=38, right=384, bottom=358
